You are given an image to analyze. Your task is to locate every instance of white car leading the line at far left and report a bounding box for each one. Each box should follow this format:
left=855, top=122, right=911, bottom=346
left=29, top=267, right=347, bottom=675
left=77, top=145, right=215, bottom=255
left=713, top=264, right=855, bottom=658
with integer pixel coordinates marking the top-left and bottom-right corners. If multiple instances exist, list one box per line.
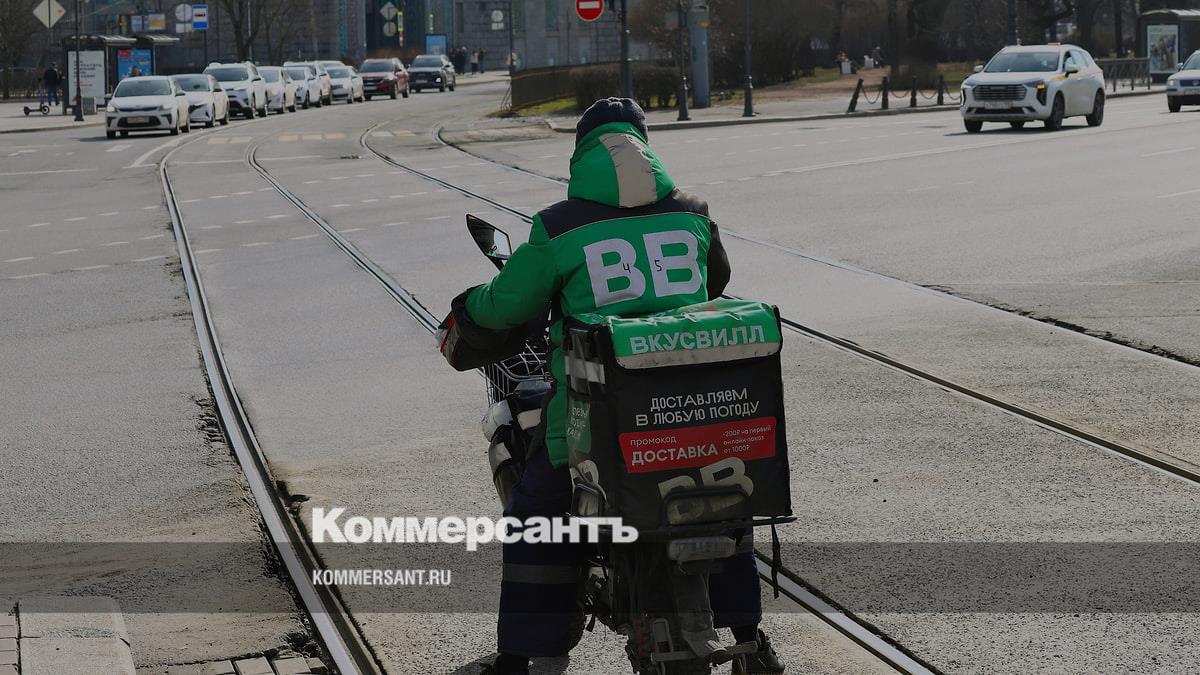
left=104, top=76, right=192, bottom=138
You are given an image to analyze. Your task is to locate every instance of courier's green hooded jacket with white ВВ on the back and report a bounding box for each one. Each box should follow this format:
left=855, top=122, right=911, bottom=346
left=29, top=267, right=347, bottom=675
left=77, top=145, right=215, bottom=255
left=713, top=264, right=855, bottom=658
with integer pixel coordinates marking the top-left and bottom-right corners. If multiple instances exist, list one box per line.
left=466, top=123, right=730, bottom=466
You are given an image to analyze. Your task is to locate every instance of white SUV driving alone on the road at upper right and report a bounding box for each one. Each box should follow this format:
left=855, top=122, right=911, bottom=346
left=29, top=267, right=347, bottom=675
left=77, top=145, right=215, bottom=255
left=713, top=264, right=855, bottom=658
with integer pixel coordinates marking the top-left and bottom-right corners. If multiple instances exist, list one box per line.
left=961, top=44, right=1104, bottom=133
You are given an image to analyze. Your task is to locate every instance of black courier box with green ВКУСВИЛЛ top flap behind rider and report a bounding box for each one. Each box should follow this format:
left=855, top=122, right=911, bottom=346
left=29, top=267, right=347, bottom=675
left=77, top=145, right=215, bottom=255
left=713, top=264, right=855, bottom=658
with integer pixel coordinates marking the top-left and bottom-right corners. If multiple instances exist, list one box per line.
left=563, top=299, right=791, bottom=536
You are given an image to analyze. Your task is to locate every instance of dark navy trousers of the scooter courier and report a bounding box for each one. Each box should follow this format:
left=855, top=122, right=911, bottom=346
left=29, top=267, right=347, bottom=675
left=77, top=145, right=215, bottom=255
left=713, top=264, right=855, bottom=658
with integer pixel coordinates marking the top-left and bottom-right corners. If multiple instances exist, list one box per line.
left=497, top=443, right=762, bottom=657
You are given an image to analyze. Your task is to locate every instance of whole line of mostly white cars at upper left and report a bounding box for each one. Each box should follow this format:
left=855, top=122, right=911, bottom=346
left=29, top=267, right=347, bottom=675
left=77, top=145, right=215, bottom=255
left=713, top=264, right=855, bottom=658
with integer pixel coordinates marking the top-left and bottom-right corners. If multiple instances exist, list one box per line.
left=104, top=55, right=457, bottom=138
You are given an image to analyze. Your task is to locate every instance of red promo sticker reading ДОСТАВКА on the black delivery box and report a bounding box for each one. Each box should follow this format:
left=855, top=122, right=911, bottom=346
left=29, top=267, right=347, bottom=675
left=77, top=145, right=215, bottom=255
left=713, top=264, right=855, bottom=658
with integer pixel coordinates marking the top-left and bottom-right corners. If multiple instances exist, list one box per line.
left=618, top=417, right=775, bottom=473
